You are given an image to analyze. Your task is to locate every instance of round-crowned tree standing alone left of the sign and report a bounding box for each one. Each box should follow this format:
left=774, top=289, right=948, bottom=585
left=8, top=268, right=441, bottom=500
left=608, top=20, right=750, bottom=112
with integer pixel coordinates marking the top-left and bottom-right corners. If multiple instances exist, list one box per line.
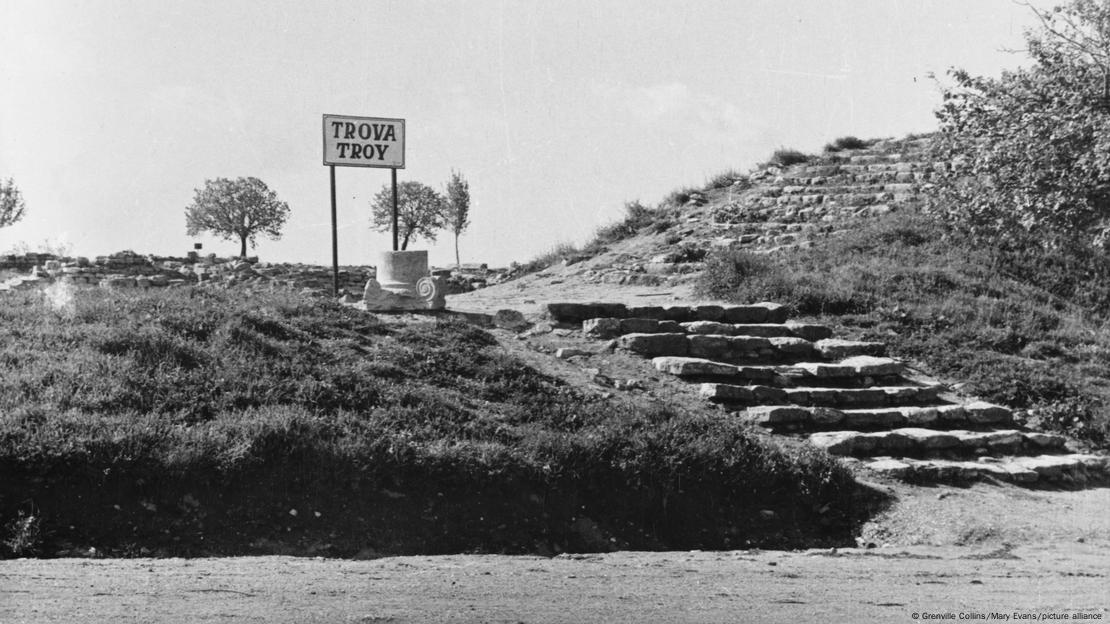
left=185, top=178, right=289, bottom=258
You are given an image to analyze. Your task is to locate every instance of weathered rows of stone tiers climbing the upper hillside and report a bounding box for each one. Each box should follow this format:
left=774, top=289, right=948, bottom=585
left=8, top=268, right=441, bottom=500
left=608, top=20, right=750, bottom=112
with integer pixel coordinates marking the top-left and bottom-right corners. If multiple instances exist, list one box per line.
left=566, top=137, right=946, bottom=285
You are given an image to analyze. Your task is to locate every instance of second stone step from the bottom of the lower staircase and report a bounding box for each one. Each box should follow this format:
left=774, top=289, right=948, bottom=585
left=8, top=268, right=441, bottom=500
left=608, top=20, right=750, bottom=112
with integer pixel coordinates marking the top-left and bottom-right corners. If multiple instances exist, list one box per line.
left=809, top=427, right=1067, bottom=457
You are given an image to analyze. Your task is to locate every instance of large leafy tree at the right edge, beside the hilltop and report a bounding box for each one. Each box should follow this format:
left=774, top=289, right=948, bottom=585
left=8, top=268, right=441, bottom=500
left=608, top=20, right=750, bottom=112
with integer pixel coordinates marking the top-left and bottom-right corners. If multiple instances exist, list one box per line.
left=930, top=0, right=1110, bottom=249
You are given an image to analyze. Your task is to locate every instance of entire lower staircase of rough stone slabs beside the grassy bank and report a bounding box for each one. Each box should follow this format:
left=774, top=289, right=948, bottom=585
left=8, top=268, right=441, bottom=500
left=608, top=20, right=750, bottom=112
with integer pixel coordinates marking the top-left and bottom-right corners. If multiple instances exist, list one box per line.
left=546, top=303, right=1110, bottom=484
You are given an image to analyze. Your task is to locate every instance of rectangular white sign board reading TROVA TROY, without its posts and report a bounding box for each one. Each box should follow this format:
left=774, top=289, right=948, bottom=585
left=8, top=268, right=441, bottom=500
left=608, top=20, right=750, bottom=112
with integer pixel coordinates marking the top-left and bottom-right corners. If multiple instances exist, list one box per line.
left=324, top=114, right=405, bottom=169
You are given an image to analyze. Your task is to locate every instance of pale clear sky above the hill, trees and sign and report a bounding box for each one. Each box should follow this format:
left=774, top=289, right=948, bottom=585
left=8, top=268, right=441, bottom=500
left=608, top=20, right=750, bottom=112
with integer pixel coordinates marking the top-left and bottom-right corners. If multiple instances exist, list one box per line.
left=0, top=0, right=1051, bottom=265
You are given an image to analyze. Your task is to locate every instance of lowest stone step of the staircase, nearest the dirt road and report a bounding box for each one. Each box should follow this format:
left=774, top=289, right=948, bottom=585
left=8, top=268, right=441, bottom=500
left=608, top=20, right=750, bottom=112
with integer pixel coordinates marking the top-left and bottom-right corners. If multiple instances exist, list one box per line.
left=862, top=453, right=1110, bottom=484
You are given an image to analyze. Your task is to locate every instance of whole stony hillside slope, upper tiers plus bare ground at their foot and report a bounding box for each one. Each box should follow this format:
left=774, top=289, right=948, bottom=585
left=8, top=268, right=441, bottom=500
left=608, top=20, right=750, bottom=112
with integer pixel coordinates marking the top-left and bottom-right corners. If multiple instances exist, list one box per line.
left=452, top=137, right=942, bottom=310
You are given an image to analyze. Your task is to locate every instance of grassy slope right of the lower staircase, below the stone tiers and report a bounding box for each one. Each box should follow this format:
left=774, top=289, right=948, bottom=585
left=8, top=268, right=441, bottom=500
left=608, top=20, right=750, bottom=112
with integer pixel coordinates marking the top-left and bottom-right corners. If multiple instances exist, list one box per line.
left=699, top=212, right=1110, bottom=446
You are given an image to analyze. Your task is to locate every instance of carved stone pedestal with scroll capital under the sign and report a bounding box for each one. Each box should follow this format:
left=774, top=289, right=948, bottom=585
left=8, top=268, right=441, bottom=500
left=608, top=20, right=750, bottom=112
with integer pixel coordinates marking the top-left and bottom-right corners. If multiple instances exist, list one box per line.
left=362, top=250, right=447, bottom=312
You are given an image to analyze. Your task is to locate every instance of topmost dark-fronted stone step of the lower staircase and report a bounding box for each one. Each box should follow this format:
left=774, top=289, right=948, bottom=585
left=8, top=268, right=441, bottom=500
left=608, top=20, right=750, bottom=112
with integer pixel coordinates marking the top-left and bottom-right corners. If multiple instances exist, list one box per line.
left=545, top=302, right=788, bottom=324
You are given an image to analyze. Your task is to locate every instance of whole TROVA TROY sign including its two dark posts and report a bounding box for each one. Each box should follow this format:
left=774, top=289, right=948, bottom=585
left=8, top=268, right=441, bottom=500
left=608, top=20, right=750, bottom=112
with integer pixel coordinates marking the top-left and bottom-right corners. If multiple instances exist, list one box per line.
left=324, top=114, right=405, bottom=296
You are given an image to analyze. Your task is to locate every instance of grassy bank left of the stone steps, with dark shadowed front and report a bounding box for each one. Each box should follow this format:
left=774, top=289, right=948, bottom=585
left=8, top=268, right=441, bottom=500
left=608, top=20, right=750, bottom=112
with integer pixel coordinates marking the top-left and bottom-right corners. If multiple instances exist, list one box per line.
left=0, top=288, right=856, bottom=554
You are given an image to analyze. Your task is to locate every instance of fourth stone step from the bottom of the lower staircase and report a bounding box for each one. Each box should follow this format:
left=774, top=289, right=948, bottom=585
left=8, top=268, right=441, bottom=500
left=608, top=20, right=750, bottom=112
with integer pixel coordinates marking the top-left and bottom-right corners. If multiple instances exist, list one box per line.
left=699, top=383, right=941, bottom=408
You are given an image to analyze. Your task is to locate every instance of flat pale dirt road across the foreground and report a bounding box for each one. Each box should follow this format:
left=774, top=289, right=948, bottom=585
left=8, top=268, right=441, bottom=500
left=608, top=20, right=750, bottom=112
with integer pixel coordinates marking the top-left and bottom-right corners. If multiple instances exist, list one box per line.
left=0, top=543, right=1110, bottom=623
